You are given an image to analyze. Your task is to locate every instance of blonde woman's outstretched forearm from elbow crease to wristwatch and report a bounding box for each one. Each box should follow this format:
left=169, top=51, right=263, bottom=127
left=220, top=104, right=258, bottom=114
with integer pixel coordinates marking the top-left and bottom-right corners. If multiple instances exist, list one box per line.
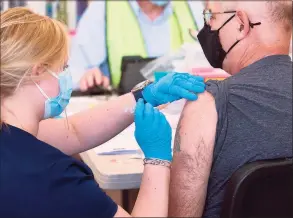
left=69, top=93, right=136, bottom=153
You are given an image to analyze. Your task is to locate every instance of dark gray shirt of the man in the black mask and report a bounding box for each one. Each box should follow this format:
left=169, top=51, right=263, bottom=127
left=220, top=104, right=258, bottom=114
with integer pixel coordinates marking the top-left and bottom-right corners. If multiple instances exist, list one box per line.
left=203, top=55, right=292, bottom=218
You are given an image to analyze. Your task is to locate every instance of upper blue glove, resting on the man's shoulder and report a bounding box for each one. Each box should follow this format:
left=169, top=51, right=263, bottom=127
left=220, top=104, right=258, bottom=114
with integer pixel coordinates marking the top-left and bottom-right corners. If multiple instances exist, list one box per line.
left=142, top=73, right=205, bottom=107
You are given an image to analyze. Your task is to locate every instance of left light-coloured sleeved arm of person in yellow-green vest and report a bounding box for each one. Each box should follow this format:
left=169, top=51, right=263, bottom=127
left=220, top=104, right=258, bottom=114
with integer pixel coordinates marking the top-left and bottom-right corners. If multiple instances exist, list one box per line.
left=68, top=1, right=106, bottom=88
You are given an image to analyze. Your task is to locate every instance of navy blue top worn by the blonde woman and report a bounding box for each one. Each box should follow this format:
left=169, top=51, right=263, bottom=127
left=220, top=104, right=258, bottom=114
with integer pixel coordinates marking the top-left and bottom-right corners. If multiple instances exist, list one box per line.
left=0, top=124, right=117, bottom=218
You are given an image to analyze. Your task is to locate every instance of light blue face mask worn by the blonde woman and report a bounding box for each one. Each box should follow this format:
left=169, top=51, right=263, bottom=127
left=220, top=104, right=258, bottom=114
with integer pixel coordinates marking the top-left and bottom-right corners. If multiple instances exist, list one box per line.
left=36, top=70, right=72, bottom=119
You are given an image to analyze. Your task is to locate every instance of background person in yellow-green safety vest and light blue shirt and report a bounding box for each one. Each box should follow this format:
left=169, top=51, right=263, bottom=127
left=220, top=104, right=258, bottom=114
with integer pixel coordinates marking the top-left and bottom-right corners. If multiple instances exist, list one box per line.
left=69, top=0, right=204, bottom=91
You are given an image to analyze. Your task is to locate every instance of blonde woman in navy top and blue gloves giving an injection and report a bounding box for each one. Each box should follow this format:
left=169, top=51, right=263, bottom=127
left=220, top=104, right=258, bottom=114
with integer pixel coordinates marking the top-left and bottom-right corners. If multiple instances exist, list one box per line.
left=0, top=8, right=204, bottom=218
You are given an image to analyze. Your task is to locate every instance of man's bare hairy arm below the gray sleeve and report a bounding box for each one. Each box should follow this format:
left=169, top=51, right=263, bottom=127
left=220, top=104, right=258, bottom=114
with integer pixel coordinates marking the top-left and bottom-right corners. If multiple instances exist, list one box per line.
left=169, top=92, right=218, bottom=217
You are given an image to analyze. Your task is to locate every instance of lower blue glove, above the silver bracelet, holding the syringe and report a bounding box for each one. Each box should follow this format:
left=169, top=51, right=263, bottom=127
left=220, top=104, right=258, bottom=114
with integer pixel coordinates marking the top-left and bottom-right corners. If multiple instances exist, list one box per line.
left=134, top=99, right=172, bottom=161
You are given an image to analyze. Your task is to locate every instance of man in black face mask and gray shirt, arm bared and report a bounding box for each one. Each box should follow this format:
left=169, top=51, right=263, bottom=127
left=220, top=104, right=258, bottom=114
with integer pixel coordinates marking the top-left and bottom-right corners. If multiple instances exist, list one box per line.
left=169, top=1, right=292, bottom=218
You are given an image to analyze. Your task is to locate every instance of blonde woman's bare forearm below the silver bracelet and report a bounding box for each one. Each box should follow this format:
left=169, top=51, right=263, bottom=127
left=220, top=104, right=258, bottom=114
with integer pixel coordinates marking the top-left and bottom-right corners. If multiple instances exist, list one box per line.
left=131, top=165, right=170, bottom=217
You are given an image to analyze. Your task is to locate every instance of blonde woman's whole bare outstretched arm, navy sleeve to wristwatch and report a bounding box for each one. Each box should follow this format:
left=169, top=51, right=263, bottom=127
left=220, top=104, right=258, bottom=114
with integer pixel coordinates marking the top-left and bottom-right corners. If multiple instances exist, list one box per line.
left=37, top=93, right=136, bottom=155
